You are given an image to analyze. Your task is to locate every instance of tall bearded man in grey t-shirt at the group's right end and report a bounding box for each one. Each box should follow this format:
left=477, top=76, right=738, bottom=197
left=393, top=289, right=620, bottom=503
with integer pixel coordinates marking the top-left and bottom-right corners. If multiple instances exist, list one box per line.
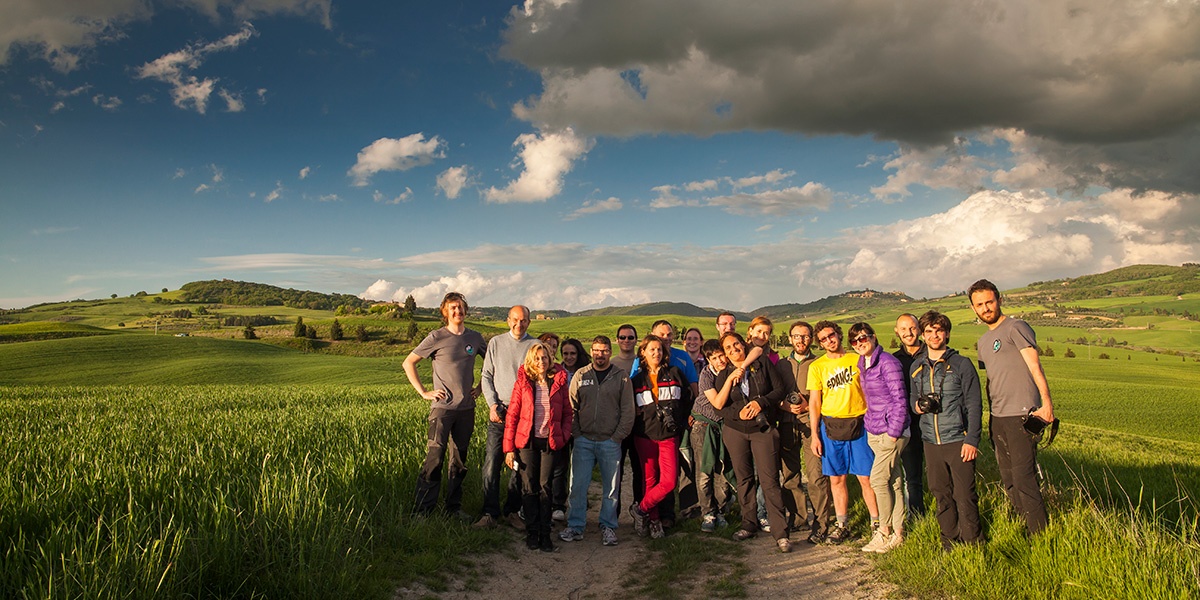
left=967, top=280, right=1054, bottom=534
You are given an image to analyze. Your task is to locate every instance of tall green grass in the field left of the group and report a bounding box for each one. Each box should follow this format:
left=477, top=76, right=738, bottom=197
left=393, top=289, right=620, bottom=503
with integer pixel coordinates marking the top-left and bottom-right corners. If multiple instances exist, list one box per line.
left=0, top=385, right=498, bottom=598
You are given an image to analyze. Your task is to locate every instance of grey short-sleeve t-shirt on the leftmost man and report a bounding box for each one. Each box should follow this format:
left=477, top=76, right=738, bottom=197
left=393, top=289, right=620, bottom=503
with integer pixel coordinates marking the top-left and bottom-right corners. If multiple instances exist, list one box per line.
left=413, top=328, right=487, bottom=410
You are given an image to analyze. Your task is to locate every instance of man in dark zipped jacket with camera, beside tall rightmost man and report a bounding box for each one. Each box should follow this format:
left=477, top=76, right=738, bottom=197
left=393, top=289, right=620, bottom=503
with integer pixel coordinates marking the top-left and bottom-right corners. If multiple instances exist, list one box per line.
left=910, top=311, right=983, bottom=551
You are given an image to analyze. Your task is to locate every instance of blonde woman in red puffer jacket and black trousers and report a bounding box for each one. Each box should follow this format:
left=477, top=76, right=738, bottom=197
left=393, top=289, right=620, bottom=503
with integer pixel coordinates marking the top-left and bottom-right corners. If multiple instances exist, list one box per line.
left=504, top=342, right=572, bottom=552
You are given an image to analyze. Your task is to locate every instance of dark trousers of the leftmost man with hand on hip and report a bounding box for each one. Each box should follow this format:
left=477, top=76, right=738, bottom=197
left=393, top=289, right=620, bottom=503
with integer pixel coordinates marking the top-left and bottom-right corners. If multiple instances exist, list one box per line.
left=414, top=410, right=475, bottom=514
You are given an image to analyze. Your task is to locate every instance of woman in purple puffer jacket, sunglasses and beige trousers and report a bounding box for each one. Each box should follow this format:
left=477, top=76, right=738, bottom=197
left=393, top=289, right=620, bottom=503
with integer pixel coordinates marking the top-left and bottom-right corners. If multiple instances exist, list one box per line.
left=848, top=323, right=908, bottom=553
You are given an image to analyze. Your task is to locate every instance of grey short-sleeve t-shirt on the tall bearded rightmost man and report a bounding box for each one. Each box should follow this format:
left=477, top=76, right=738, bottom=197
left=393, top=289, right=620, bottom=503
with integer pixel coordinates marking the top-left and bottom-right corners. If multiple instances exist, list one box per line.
left=976, top=317, right=1042, bottom=416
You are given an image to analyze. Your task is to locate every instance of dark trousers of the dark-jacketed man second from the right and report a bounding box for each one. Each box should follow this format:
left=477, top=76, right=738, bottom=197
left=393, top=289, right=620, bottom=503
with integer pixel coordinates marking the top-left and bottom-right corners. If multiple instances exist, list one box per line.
left=920, top=442, right=983, bottom=550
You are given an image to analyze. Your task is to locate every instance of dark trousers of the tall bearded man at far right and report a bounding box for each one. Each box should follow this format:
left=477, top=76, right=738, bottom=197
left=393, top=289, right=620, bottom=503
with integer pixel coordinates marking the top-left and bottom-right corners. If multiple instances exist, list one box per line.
left=990, top=416, right=1050, bottom=534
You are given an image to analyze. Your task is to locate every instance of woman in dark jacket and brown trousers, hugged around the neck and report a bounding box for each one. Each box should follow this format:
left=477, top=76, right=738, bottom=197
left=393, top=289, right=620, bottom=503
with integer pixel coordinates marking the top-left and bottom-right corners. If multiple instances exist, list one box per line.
left=712, top=331, right=792, bottom=552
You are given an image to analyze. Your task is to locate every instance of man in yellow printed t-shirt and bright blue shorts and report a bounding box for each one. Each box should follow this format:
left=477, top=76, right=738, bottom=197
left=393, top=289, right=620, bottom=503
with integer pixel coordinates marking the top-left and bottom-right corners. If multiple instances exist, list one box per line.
left=808, top=320, right=880, bottom=544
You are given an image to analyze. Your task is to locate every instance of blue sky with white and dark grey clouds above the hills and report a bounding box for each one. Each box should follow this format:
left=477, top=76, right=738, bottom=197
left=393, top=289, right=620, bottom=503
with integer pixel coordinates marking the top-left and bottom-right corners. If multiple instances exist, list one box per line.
left=0, top=0, right=1200, bottom=311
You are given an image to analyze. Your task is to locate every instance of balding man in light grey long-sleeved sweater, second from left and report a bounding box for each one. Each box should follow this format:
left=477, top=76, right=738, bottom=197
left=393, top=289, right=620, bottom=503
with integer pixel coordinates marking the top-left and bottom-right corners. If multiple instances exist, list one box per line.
left=475, top=306, right=538, bottom=529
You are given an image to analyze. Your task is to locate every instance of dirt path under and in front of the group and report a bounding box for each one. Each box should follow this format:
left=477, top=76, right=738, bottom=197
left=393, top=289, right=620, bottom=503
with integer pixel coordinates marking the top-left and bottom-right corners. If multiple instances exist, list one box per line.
left=395, top=468, right=895, bottom=600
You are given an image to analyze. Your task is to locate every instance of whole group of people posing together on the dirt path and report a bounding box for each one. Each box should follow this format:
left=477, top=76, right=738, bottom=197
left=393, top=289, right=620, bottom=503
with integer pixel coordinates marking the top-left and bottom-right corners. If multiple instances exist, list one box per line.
left=404, top=280, right=1054, bottom=553
